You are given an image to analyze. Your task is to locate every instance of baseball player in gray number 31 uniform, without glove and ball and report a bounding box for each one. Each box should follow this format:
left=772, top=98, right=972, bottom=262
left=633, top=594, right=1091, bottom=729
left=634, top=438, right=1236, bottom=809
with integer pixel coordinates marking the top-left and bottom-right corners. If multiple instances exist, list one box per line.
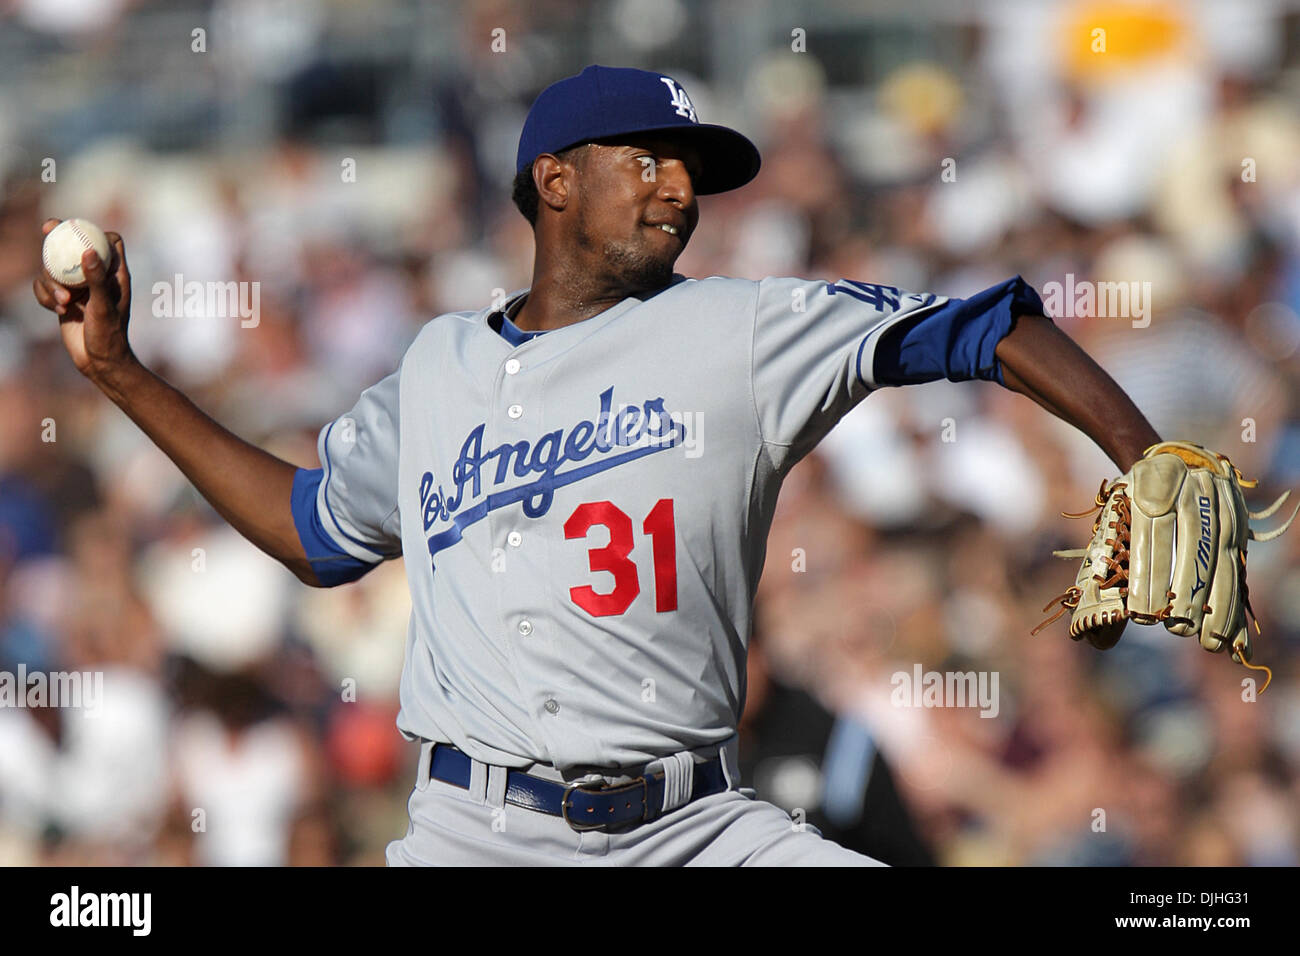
left=35, top=66, right=1158, bottom=865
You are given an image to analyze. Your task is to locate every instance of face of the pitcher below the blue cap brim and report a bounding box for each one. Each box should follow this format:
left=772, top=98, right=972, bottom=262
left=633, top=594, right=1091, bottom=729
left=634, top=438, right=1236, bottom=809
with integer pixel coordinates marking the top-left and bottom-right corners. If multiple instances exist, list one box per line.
left=571, top=137, right=699, bottom=291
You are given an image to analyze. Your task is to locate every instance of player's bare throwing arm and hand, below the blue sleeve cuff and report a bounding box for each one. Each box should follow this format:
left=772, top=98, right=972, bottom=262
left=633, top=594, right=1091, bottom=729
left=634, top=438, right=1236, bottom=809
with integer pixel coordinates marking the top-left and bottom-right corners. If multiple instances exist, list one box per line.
left=34, top=220, right=320, bottom=587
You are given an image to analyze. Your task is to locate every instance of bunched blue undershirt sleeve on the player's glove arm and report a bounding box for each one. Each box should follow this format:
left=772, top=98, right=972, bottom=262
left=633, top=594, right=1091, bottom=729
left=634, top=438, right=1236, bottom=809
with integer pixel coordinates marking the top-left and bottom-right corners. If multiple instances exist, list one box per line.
left=874, top=276, right=1043, bottom=385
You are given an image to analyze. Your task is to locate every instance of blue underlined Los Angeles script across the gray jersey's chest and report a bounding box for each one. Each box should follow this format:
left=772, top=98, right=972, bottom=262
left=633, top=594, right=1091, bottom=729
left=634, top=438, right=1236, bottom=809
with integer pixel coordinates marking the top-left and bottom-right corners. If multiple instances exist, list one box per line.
left=420, top=385, right=686, bottom=558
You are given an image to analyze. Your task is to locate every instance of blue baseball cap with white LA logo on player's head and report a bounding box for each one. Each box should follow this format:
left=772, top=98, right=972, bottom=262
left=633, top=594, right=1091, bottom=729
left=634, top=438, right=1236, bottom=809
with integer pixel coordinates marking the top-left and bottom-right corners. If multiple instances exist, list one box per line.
left=515, top=66, right=761, bottom=195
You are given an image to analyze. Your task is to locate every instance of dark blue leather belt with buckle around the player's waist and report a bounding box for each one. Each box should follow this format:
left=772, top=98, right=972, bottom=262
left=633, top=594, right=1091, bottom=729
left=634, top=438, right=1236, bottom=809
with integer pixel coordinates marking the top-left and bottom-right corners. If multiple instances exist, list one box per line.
left=429, top=744, right=728, bottom=832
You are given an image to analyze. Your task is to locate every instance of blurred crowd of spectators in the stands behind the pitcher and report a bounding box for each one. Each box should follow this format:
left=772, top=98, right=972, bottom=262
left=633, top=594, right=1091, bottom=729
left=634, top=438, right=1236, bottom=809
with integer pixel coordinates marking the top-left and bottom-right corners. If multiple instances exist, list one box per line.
left=0, top=0, right=1300, bottom=865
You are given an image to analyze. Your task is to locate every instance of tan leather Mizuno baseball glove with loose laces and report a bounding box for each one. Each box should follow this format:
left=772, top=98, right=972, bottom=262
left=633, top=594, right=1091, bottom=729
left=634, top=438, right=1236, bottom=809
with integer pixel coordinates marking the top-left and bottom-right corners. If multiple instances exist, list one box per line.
left=1031, top=441, right=1300, bottom=687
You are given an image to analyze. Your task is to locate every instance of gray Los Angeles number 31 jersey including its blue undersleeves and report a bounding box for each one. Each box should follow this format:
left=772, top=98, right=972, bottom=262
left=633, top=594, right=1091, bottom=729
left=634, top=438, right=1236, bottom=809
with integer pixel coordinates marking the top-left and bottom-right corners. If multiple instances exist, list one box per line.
left=294, top=276, right=1041, bottom=773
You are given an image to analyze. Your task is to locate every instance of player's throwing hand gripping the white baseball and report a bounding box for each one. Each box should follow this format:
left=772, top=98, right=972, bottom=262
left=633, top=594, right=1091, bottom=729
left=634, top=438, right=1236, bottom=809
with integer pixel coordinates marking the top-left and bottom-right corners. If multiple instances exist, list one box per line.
left=31, top=219, right=134, bottom=390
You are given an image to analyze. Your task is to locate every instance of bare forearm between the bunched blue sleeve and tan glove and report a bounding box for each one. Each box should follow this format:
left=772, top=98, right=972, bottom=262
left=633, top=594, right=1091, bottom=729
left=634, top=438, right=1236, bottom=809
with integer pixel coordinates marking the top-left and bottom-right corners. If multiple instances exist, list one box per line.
left=995, top=312, right=1160, bottom=472
